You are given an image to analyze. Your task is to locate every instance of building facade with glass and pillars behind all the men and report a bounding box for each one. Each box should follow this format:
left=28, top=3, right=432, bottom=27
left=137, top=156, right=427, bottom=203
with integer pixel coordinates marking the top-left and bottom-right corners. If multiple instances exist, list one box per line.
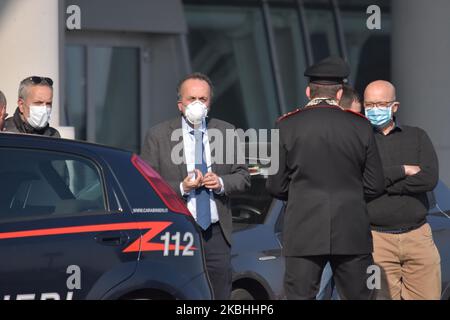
left=0, top=0, right=450, bottom=184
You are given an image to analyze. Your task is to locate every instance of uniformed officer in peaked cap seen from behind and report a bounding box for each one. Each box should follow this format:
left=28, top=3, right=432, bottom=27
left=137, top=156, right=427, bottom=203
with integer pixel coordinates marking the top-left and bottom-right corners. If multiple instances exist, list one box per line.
left=267, top=58, right=383, bottom=299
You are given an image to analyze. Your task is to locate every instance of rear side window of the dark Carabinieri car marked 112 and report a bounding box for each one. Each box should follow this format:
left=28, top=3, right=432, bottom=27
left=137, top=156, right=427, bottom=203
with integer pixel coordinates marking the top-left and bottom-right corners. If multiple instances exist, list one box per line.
left=0, top=148, right=106, bottom=221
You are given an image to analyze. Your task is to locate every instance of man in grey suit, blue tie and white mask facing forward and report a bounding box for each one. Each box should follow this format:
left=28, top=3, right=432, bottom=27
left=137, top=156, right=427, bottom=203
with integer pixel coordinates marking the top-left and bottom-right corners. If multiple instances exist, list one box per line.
left=141, top=73, right=250, bottom=300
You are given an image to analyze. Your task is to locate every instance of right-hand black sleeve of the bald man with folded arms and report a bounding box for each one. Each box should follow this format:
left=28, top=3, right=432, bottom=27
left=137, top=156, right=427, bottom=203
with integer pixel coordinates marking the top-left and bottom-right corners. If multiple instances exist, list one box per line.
left=386, top=130, right=439, bottom=195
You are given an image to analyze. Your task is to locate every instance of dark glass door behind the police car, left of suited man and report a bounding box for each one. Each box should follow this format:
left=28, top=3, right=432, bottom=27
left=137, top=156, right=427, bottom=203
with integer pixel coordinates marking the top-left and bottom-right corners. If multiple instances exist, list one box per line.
left=63, top=36, right=148, bottom=152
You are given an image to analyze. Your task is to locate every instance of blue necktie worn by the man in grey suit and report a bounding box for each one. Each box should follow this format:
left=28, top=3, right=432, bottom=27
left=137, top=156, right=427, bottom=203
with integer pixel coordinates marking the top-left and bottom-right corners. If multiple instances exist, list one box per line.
left=194, top=129, right=211, bottom=230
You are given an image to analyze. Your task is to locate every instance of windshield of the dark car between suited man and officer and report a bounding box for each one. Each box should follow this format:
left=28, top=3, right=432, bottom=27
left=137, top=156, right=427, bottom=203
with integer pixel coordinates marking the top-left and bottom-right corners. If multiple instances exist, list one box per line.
left=230, top=165, right=273, bottom=224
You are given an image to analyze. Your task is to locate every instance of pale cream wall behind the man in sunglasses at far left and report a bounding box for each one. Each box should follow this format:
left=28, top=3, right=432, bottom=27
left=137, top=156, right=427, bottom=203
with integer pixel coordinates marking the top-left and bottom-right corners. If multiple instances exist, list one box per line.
left=0, top=0, right=61, bottom=131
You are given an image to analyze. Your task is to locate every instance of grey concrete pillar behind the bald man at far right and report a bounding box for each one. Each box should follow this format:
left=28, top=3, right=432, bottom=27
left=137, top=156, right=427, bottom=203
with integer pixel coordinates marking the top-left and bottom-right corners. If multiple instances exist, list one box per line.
left=392, top=0, right=450, bottom=186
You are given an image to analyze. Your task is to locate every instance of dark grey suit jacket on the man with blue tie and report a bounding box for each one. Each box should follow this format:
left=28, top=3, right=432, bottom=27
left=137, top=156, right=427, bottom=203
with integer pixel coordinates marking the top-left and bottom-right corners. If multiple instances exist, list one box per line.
left=141, top=117, right=250, bottom=244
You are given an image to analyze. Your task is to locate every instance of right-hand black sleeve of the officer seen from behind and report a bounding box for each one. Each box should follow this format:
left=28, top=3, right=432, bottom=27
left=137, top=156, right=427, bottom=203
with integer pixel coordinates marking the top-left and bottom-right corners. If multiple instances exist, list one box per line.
left=363, top=131, right=384, bottom=201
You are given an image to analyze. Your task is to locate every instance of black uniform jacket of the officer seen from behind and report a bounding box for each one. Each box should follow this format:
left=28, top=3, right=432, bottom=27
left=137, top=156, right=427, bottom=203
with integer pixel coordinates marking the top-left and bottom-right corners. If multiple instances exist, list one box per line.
left=267, top=104, right=384, bottom=256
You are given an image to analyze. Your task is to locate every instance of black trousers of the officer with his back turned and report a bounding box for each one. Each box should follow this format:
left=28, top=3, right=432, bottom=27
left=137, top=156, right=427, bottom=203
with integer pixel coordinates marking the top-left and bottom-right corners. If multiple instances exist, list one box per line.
left=284, top=254, right=375, bottom=300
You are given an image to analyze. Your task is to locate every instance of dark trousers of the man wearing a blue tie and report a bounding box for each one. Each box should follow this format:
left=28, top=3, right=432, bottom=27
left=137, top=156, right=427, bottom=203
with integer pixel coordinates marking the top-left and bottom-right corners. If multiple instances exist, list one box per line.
left=202, top=223, right=232, bottom=300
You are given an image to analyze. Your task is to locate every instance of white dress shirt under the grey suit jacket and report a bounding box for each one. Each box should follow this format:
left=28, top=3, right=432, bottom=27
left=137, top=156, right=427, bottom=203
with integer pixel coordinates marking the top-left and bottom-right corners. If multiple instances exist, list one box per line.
left=180, top=117, right=225, bottom=223
